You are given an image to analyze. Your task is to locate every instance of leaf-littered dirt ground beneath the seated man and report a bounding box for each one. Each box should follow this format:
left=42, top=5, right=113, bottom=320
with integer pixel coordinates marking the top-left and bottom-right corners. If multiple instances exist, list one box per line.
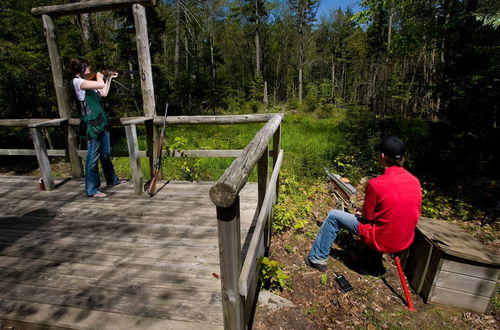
left=253, top=184, right=500, bottom=330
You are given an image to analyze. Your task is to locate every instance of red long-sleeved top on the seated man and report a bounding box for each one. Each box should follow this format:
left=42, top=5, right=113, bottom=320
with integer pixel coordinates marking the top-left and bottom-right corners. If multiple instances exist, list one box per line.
left=358, top=166, right=422, bottom=253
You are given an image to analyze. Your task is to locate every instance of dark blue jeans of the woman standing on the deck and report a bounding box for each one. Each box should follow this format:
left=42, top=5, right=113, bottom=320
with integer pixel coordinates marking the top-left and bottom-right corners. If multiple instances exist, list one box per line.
left=85, top=132, right=119, bottom=196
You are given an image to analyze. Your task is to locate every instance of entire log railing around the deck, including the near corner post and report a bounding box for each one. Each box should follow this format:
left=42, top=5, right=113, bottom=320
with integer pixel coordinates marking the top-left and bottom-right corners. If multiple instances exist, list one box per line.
left=0, top=114, right=283, bottom=329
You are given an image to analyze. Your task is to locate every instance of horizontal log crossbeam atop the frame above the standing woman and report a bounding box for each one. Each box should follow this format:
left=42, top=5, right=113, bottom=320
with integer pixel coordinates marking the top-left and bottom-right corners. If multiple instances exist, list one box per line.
left=31, top=0, right=156, bottom=17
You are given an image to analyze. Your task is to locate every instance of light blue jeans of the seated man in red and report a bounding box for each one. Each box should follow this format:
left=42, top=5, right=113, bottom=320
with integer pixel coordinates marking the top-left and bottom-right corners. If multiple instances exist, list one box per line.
left=309, top=210, right=359, bottom=265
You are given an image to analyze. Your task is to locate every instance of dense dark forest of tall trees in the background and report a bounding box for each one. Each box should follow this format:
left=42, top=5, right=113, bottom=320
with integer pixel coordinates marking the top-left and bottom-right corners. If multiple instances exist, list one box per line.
left=0, top=0, right=500, bottom=204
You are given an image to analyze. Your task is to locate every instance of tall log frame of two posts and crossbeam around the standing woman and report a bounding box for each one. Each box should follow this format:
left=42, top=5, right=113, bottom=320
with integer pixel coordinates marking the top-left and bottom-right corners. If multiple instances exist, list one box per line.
left=31, top=0, right=156, bottom=178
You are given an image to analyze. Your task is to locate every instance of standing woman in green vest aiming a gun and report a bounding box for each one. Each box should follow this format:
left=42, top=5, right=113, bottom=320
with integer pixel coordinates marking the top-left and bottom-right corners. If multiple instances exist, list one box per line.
left=70, top=58, right=121, bottom=198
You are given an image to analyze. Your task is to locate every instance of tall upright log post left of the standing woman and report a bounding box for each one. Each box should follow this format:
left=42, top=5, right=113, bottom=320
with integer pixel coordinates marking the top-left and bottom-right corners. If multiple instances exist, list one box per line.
left=42, top=15, right=83, bottom=178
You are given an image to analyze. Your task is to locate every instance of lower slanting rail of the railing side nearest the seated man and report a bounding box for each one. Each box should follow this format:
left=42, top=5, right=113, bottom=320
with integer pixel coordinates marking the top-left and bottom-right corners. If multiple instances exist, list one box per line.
left=239, top=150, right=283, bottom=297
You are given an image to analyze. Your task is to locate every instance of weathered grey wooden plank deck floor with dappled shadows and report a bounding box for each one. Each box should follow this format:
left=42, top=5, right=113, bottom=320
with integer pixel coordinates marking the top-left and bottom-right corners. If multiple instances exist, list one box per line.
left=0, top=176, right=257, bottom=329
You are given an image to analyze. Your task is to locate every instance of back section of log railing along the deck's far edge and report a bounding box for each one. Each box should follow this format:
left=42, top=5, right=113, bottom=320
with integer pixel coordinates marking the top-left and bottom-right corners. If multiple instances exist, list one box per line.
left=0, top=114, right=282, bottom=194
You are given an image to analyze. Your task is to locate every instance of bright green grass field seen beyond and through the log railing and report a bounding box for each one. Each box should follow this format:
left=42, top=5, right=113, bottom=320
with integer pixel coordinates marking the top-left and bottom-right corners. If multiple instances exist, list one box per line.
left=109, top=111, right=350, bottom=181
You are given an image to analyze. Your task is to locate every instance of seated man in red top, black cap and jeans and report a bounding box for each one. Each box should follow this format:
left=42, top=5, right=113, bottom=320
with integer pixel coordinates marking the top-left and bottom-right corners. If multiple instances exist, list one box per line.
left=305, top=136, right=422, bottom=272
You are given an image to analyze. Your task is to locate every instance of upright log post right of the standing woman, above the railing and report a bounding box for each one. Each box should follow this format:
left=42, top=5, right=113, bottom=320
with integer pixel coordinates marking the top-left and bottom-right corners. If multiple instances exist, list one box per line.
left=132, top=4, right=155, bottom=117
